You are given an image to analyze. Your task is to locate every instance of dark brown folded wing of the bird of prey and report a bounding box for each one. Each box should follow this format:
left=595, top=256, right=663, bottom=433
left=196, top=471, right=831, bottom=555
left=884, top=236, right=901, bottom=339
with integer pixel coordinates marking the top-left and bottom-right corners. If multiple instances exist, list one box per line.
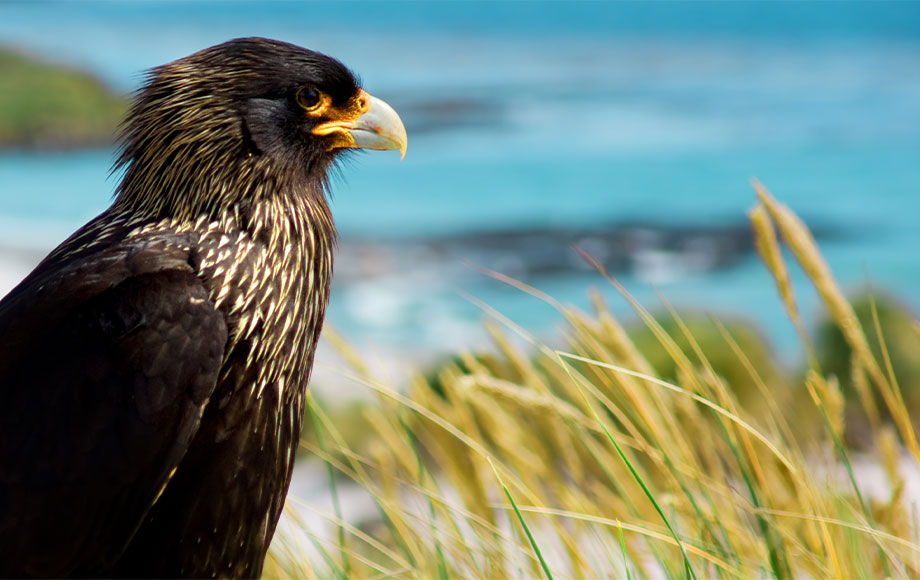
left=0, top=232, right=227, bottom=577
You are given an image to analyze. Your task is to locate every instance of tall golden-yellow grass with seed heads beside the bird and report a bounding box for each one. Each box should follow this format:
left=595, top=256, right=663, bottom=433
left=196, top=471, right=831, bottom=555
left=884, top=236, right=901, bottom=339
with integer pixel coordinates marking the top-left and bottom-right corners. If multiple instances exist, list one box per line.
left=265, top=184, right=920, bottom=579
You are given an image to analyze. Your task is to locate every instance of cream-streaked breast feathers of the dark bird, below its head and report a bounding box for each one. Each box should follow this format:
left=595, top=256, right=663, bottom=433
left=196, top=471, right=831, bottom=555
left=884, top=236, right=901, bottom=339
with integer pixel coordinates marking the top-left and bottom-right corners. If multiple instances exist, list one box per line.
left=129, top=193, right=334, bottom=406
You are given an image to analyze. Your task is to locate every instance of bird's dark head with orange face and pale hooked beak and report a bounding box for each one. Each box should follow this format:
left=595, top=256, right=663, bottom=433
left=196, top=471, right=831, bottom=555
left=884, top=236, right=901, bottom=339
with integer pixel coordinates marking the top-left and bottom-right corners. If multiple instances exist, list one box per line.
left=116, top=38, right=406, bottom=218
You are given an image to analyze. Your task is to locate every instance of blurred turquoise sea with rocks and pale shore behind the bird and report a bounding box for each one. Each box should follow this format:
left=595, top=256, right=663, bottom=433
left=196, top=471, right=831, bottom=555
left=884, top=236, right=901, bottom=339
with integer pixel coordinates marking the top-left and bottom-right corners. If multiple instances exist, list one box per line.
left=0, top=2, right=920, bottom=370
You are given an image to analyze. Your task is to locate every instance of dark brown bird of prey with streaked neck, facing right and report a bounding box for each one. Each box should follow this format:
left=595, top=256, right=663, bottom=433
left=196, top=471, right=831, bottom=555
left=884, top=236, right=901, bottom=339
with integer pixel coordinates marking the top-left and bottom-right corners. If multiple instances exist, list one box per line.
left=0, top=37, right=407, bottom=578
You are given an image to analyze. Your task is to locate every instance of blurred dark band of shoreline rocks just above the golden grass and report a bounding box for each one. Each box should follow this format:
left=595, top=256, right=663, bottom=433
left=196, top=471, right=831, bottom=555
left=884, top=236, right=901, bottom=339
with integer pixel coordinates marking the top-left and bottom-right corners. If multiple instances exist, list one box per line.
left=336, top=222, right=831, bottom=284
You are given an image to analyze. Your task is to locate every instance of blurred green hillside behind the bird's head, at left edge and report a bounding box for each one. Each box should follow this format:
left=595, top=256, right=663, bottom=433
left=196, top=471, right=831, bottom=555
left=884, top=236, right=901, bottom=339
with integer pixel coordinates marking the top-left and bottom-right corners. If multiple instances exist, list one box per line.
left=0, top=48, right=127, bottom=149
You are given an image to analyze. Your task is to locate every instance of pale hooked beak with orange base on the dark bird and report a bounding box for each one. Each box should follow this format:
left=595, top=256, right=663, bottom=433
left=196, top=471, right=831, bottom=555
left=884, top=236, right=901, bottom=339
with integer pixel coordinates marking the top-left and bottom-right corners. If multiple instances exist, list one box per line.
left=313, top=91, right=408, bottom=159
